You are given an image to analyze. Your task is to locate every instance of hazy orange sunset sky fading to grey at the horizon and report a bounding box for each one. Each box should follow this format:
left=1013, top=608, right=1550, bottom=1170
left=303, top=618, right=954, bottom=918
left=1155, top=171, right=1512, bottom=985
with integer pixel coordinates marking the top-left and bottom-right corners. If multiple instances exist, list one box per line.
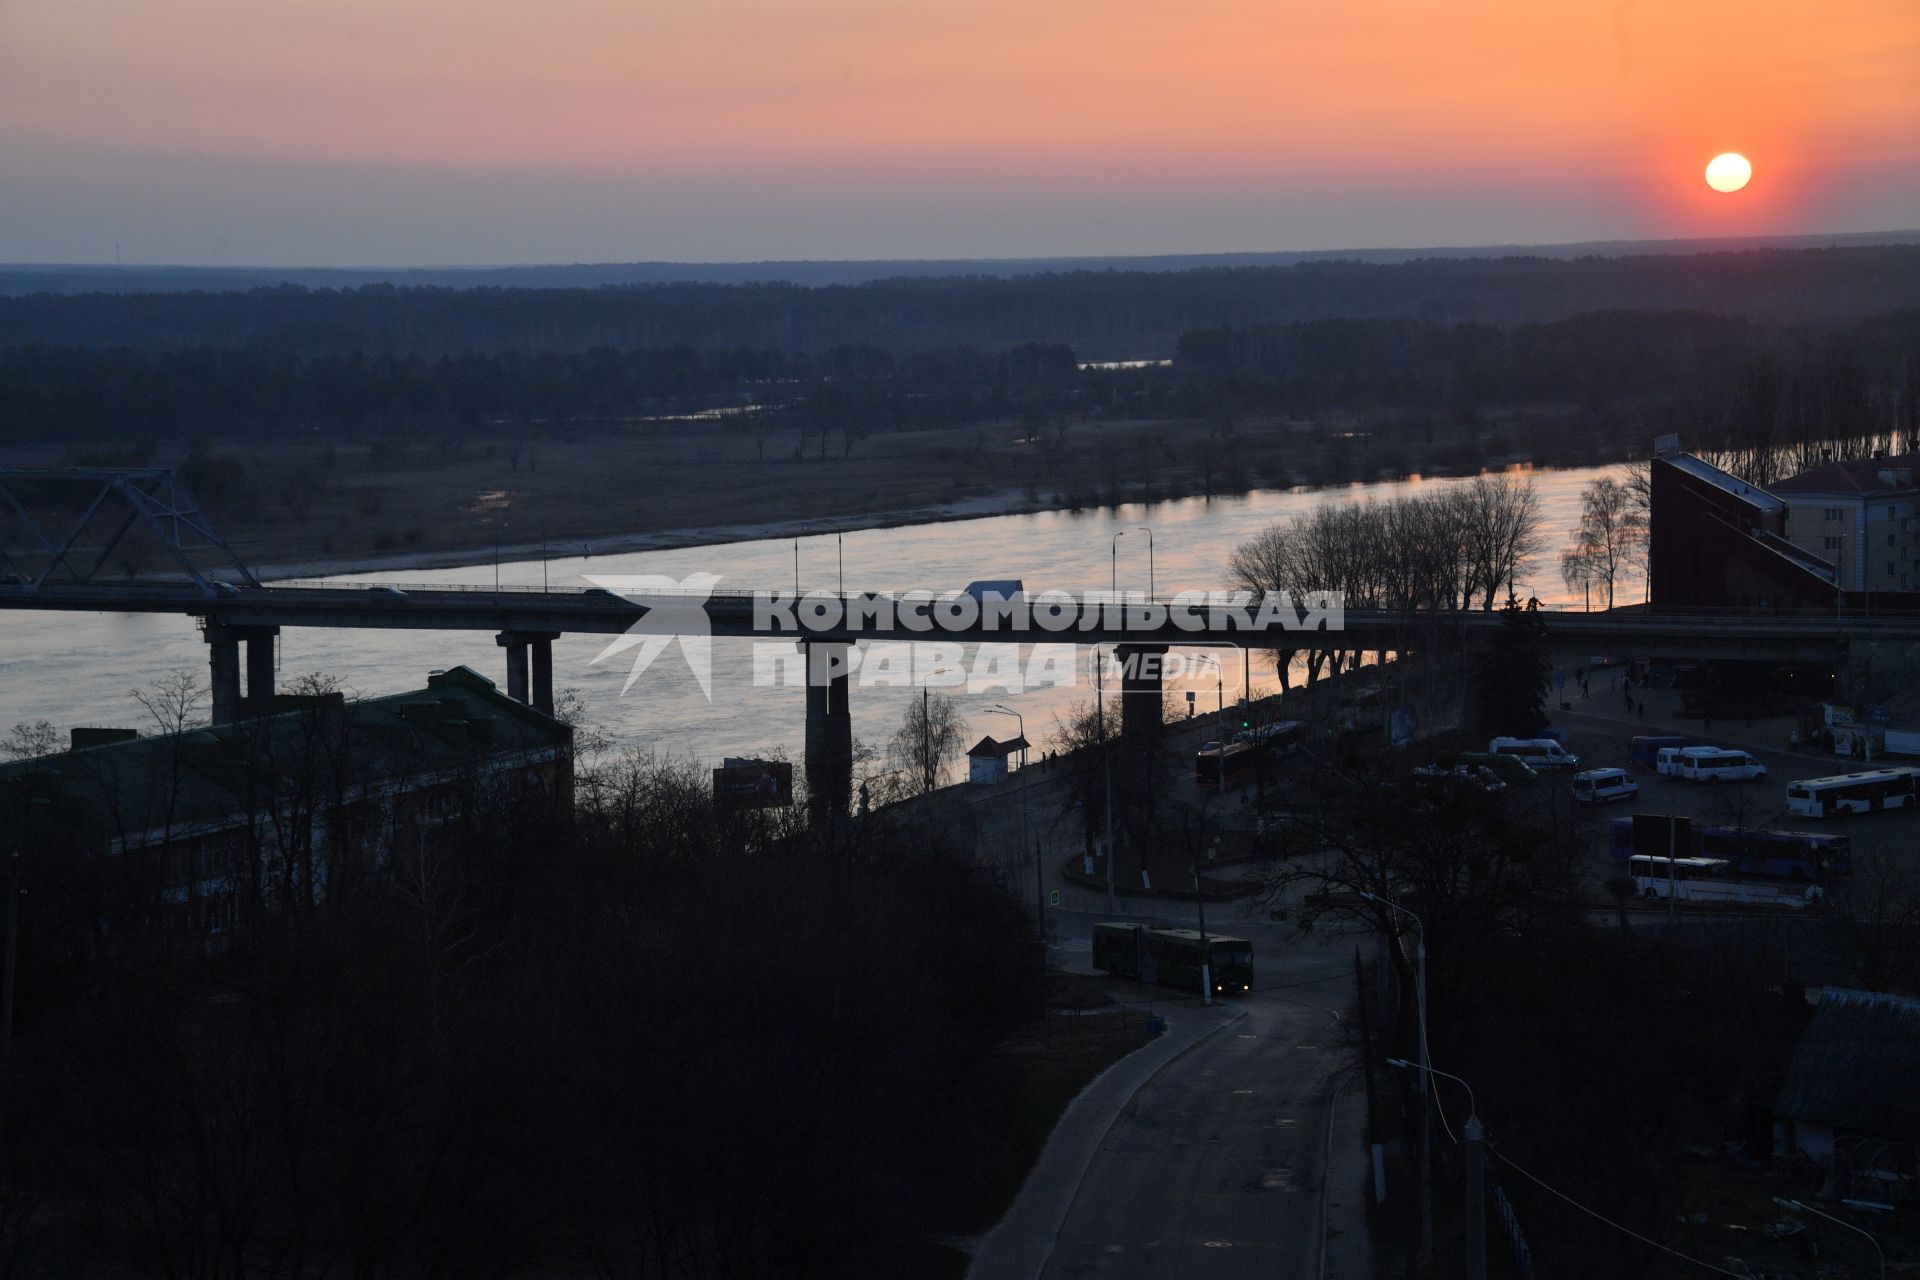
left=0, top=0, right=1920, bottom=263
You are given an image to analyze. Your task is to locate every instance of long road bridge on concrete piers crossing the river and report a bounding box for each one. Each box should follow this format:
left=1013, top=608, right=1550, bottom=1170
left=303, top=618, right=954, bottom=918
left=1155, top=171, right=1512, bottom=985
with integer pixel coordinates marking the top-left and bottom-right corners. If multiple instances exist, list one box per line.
left=0, top=580, right=1920, bottom=817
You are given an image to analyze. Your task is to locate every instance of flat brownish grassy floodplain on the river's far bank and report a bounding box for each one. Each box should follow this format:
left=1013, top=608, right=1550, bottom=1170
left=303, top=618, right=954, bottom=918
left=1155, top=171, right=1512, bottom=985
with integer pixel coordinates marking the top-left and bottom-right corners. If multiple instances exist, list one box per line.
left=11, top=402, right=1605, bottom=574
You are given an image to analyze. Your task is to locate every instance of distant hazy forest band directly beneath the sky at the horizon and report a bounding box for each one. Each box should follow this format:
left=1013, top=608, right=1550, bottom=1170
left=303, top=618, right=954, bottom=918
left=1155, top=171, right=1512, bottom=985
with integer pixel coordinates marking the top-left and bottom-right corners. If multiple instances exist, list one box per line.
left=0, top=246, right=1920, bottom=357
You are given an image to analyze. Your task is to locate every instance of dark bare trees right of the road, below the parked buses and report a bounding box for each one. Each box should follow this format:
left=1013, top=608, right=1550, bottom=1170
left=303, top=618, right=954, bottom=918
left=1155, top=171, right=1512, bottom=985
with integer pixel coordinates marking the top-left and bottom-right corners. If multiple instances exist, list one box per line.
left=1271, top=758, right=1811, bottom=1280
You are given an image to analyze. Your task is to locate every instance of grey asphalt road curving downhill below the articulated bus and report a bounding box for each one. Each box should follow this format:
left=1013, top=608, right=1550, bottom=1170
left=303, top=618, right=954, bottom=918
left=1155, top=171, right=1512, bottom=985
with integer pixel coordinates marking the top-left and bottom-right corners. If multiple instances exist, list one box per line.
left=1041, top=912, right=1357, bottom=1280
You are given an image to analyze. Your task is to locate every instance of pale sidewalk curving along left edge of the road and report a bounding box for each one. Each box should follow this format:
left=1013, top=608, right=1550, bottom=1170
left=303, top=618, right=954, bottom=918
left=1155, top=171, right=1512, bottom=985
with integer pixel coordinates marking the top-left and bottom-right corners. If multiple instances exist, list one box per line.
left=966, top=1006, right=1246, bottom=1280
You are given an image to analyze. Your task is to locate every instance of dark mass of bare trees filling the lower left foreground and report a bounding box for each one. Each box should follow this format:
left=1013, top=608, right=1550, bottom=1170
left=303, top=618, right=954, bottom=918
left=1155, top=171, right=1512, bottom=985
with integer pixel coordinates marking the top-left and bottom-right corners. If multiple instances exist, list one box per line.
left=0, top=760, right=1035, bottom=1278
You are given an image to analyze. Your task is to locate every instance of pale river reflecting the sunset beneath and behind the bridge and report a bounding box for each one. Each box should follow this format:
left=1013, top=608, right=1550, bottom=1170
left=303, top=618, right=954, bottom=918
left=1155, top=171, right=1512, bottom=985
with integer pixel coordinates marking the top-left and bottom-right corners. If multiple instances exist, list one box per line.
left=0, top=468, right=1640, bottom=773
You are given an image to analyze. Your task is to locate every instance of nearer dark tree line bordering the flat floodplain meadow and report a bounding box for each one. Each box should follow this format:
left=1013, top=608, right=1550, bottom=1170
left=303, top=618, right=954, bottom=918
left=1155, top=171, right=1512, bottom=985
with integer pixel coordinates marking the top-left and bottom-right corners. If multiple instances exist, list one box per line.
left=0, top=311, right=1920, bottom=478
